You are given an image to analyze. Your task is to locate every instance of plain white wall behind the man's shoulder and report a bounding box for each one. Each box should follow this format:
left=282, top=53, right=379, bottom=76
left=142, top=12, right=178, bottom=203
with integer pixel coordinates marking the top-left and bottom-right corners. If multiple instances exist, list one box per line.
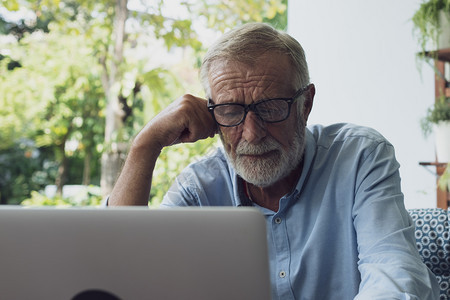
left=288, top=0, right=436, bottom=208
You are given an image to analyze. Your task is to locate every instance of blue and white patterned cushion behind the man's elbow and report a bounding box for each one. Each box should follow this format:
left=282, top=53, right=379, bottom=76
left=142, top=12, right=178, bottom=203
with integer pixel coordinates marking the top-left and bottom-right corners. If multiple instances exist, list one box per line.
left=408, top=208, right=450, bottom=300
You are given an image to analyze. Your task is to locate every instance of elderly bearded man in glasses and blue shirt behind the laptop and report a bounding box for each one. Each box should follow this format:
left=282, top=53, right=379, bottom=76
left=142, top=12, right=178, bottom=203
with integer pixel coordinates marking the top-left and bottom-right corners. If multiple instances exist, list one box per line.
left=109, top=24, right=438, bottom=300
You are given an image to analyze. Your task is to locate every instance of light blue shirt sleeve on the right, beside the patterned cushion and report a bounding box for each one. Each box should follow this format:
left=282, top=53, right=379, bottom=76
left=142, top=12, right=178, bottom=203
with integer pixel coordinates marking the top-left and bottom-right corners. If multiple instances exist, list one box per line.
left=353, top=142, right=439, bottom=300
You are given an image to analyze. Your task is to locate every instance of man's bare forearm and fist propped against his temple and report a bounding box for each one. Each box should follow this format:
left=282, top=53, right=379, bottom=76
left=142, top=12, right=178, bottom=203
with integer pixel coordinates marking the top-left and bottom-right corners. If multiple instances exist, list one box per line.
left=108, top=95, right=217, bottom=206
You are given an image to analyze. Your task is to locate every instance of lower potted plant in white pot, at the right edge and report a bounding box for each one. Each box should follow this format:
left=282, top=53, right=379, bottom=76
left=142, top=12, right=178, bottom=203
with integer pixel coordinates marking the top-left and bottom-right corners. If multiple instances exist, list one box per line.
left=421, top=97, right=450, bottom=162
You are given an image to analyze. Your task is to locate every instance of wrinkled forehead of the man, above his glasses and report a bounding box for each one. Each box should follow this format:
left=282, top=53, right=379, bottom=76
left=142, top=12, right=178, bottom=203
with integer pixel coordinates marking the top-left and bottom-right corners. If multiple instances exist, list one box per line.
left=209, top=53, right=297, bottom=104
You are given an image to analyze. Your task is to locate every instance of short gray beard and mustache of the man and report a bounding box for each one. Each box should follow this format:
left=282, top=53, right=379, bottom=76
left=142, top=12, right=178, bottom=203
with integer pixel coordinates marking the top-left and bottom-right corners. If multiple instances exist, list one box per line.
left=220, top=122, right=306, bottom=187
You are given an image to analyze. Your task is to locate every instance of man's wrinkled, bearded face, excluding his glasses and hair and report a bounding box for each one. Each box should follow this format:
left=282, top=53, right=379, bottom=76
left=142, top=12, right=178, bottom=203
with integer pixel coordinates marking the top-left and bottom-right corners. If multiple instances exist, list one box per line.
left=209, top=53, right=305, bottom=187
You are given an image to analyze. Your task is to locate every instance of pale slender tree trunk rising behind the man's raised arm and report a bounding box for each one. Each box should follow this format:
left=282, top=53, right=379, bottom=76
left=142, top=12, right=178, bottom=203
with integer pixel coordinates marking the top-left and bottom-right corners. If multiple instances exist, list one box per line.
left=101, top=0, right=128, bottom=196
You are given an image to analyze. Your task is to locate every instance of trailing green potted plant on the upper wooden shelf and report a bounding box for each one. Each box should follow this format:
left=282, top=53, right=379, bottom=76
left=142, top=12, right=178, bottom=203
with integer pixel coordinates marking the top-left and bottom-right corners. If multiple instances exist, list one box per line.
left=412, top=0, right=450, bottom=51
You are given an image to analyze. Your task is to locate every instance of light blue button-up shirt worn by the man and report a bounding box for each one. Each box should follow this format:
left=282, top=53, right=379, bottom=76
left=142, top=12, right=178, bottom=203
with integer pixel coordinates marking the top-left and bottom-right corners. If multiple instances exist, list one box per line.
left=162, top=124, right=439, bottom=300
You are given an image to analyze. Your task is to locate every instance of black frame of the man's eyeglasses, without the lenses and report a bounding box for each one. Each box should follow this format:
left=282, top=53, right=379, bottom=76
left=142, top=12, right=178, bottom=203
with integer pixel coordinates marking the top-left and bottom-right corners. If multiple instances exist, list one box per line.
left=207, top=84, right=310, bottom=127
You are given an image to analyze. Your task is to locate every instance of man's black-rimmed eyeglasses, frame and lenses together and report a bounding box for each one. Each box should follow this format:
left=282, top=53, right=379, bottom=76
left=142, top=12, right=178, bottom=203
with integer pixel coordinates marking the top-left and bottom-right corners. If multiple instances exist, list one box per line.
left=208, top=85, right=309, bottom=127
